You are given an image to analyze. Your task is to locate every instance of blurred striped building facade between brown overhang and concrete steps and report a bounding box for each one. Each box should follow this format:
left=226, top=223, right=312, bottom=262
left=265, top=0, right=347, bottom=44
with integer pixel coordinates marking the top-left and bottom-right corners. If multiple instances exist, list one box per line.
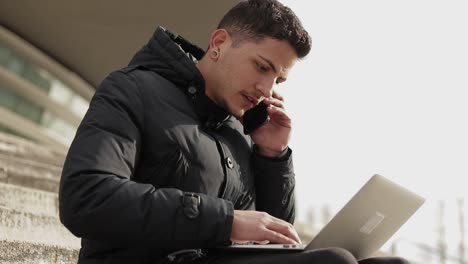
left=0, top=27, right=94, bottom=151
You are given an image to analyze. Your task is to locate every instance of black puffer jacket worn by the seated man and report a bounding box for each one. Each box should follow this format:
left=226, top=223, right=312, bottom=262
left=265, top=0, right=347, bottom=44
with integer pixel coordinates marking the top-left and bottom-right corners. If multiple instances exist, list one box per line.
left=59, top=28, right=294, bottom=263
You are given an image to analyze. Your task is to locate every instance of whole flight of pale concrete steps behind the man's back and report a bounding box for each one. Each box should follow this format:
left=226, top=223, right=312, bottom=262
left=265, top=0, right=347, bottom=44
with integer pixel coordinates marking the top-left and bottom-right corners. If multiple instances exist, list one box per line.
left=0, top=133, right=80, bottom=264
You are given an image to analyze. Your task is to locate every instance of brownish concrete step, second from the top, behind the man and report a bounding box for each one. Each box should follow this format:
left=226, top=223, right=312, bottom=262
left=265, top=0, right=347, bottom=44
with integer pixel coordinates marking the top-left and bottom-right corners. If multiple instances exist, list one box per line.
left=0, top=153, right=62, bottom=193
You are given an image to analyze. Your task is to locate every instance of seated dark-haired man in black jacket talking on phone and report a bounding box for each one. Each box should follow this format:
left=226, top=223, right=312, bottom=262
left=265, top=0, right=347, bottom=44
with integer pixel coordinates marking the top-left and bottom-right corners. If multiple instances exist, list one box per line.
left=59, top=0, right=410, bottom=263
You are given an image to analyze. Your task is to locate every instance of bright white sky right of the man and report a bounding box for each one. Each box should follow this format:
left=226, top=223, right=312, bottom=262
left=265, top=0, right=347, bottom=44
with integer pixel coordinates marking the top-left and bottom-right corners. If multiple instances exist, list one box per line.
left=278, top=0, right=468, bottom=260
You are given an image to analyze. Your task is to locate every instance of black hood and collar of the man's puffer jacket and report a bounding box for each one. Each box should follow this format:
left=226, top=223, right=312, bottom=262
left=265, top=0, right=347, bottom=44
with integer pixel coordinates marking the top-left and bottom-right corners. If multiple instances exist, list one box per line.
left=129, top=27, right=230, bottom=129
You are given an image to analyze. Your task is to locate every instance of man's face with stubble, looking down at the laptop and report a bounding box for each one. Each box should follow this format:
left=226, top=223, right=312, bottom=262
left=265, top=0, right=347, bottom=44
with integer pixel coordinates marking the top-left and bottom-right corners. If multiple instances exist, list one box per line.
left=206, top=34, right=297, bottom=118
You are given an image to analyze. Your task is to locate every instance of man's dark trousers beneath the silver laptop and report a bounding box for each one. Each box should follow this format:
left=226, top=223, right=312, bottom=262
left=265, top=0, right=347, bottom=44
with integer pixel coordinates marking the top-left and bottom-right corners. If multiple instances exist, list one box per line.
left=194, top=248, right=409, bottom=264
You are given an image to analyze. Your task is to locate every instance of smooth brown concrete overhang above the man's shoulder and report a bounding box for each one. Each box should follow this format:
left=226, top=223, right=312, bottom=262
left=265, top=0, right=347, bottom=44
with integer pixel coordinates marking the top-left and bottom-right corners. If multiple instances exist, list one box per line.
left=0, top=0, right=238, bottom=87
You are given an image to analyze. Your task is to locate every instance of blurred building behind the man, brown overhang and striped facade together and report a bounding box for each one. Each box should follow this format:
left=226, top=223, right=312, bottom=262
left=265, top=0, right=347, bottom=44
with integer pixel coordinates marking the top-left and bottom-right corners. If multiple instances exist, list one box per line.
left=0, top=0, right=237, bottom=152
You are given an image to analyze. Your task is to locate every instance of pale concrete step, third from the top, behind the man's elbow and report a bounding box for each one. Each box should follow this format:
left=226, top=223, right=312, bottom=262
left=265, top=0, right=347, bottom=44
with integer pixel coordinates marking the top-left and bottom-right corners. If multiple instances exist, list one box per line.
left=0, top=183, right=58, bottom=217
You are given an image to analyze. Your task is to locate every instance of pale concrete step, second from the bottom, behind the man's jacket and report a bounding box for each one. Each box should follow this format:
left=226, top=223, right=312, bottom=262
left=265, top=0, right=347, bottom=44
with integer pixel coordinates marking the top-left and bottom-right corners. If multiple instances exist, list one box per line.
left=0, top=207, right=80, bottom=248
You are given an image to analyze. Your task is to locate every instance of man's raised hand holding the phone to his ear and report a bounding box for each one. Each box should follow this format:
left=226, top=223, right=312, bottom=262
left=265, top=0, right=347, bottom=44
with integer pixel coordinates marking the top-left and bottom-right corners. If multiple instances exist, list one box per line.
left=250, top=91, right=292, bottom=157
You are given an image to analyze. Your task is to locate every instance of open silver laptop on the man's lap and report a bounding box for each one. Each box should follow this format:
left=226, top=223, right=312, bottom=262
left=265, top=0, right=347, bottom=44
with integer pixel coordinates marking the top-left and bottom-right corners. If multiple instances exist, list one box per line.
left=226, top=174, right=425, bottom=260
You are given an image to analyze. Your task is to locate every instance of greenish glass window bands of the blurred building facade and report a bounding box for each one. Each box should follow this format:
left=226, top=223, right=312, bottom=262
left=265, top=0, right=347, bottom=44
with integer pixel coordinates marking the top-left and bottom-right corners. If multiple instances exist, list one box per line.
left=0, top=42, right=89, bottom=146
